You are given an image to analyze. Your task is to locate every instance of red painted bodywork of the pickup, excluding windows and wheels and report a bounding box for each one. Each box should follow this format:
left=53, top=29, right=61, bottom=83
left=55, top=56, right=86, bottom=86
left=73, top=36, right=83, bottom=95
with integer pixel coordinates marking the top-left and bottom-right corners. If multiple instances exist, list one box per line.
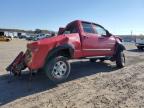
left=27, top=20, right=121, bottom=70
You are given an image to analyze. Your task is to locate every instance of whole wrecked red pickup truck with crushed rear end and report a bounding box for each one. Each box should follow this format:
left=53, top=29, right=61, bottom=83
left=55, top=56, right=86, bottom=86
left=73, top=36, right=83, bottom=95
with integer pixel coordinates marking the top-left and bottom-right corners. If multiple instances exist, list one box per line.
left=7, top=20, right=125, bottom=82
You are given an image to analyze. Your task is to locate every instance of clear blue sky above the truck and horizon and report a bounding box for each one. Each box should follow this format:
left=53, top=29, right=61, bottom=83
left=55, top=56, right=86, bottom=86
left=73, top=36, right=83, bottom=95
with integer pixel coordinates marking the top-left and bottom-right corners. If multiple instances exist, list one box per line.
left=0, top=0, right=144, bottom=35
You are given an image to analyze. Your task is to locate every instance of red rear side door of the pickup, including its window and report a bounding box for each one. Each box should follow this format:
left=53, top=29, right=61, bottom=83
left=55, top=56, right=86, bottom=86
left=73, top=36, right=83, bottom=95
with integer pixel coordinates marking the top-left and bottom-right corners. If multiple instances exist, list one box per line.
left=81, top=22, right=99, bottom=57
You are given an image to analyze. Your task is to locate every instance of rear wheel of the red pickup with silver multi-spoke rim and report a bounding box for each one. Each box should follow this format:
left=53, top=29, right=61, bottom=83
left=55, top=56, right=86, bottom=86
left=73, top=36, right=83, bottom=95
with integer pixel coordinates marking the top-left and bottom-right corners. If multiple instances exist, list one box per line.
left=45, top=56, right=71, bottom=83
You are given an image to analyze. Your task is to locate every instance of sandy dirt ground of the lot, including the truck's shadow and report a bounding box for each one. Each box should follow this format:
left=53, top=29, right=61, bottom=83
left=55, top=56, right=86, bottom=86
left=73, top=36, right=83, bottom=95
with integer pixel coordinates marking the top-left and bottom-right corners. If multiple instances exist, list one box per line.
left=0, top=39, right=144, bottom=108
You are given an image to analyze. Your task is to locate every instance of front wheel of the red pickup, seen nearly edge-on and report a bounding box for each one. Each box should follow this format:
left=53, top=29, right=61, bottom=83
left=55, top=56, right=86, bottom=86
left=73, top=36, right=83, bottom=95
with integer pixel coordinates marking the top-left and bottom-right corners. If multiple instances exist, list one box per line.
left=116, top=51, right=125, bottom=68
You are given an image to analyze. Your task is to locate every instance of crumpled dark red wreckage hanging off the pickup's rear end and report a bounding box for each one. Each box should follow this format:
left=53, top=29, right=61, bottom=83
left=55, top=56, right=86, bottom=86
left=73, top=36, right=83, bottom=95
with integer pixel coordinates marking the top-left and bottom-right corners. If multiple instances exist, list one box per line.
left=6, top=52, right=26, bottom=75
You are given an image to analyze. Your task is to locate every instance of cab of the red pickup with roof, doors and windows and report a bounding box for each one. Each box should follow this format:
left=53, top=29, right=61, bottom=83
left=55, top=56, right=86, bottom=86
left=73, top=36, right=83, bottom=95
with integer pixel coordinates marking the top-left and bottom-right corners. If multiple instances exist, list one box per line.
left=58, top=21, right=119, bottom=57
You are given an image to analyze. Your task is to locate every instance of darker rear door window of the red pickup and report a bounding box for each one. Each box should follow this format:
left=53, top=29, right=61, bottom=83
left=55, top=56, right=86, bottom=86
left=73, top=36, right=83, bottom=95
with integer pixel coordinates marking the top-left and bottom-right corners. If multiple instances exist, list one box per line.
left=82, top=22, right=95, bottom=33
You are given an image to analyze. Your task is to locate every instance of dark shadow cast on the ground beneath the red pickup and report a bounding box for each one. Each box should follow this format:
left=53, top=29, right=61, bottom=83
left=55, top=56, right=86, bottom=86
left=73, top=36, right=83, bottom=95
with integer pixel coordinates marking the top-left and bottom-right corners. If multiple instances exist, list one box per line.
left=0, top=61, right=116, bottom=106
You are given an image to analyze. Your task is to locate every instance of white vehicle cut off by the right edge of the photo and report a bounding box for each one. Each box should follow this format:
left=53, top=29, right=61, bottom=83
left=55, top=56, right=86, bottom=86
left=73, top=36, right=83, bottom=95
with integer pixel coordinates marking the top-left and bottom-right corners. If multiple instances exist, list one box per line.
left=135, top=36, right=144, bottom=50
